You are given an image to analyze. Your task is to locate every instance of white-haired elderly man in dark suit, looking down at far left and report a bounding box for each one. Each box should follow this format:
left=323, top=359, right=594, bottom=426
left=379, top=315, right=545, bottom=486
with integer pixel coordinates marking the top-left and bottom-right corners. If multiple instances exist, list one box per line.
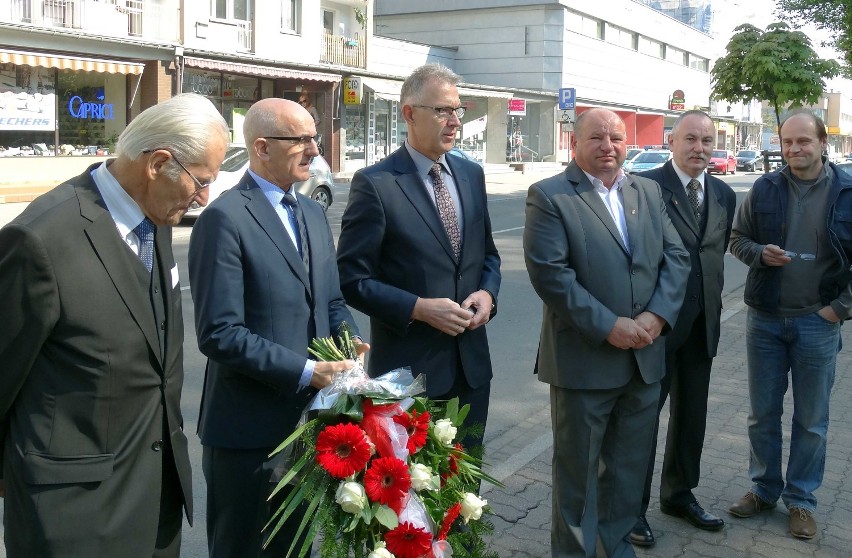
left=0, top=94, right=228, bottom=558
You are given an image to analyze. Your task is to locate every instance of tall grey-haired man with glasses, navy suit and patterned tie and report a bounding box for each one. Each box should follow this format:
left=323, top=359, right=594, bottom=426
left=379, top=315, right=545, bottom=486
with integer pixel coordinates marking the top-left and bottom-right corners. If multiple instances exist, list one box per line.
left=337, top=64, right=500, bottom=449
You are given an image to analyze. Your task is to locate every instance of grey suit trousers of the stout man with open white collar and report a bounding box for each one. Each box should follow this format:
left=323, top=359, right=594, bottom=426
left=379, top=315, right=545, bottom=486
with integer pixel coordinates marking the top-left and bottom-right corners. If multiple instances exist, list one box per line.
left=550, top=369, right=660, bottom=558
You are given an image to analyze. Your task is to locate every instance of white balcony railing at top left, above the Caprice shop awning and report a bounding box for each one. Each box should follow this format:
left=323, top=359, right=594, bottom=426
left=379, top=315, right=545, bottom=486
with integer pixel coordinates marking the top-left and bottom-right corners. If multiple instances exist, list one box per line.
left=0, top=0, right=178, bottom=40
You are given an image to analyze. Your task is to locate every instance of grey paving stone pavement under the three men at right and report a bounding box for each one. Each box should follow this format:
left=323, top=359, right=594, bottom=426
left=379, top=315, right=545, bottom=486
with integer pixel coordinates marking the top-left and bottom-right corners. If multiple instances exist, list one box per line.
left=484, top=291, right=852, bottom=558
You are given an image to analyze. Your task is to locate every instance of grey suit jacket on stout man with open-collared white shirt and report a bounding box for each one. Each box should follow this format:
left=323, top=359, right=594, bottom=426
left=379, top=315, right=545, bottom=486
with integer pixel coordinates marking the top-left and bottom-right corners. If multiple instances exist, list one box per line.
left=524, top=163, right=689, bottom=389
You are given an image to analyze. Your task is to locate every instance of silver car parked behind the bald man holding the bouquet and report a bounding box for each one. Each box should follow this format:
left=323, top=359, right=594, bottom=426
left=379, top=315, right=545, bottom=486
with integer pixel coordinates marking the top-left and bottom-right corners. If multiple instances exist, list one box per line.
left=185, top=145, right=335, bottom=219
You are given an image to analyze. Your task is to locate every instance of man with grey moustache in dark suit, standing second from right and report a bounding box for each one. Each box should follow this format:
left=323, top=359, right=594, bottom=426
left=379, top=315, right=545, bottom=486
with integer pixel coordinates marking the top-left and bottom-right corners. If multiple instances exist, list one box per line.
left=630, top=110, right=737, bottom=546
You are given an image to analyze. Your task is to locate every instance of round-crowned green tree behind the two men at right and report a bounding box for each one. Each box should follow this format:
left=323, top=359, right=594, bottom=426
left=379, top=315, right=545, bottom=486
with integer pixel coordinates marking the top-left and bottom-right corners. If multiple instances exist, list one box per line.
left=710, top=23, right=840, bottom=132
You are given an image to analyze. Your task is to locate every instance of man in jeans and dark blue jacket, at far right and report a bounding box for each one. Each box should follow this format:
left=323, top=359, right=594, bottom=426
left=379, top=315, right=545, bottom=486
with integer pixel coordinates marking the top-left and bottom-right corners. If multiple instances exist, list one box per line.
left=729, top=111, right=852, bottom=539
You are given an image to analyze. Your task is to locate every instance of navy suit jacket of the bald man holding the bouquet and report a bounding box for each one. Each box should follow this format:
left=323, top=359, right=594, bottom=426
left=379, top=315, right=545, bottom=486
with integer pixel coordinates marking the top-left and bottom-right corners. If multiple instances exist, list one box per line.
left=189, top=173, right=357, bottom=449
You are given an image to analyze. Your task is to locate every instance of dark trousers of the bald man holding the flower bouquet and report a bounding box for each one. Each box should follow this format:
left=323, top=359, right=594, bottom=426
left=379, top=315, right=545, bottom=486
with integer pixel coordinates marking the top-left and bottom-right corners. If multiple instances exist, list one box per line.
left=202, top=446, right=306, bottom=558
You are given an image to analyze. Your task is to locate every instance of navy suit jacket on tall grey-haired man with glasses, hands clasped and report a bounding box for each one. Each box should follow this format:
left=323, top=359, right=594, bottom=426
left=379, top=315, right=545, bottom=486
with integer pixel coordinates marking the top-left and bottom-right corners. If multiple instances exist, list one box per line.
left=337, top=146, right=500, bottom=396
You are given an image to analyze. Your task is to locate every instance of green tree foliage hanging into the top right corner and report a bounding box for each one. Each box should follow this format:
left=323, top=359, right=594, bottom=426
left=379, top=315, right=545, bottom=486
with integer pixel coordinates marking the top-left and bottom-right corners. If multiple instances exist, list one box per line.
left=777, top=0, right=852, bottom=78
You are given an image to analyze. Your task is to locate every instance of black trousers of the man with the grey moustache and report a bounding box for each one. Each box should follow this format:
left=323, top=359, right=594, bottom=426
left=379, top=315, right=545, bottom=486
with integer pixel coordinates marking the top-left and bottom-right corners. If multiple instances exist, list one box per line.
left=642, top=318, right=713, bottom=515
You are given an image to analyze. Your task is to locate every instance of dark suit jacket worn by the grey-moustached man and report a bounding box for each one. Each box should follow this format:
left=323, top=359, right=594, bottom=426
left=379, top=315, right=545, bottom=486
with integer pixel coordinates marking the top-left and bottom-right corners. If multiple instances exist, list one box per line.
left=637, top=161, right=737, bottom=358
